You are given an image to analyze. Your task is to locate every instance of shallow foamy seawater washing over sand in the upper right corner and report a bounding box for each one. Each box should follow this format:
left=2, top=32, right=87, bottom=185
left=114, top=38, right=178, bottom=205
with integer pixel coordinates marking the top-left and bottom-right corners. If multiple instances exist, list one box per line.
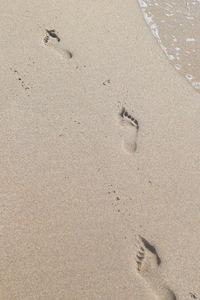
left=138, top=0, right=200, bottom=92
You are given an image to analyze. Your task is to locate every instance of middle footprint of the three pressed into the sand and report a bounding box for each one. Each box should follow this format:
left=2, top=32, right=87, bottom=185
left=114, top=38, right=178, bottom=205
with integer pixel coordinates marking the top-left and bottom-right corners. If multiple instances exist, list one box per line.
left=119, top=107, right=139, bottom=153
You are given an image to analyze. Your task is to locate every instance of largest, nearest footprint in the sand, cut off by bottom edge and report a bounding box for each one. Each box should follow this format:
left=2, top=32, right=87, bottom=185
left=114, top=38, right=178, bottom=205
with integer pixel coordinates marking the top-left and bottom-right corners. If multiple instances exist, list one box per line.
left=136, top=236, right=177, bottom=300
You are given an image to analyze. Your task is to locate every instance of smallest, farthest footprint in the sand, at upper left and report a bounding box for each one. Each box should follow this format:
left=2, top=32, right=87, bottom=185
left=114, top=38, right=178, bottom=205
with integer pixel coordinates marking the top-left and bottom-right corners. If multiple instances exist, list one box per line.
left=44, top=29, right=73, bottom=58
